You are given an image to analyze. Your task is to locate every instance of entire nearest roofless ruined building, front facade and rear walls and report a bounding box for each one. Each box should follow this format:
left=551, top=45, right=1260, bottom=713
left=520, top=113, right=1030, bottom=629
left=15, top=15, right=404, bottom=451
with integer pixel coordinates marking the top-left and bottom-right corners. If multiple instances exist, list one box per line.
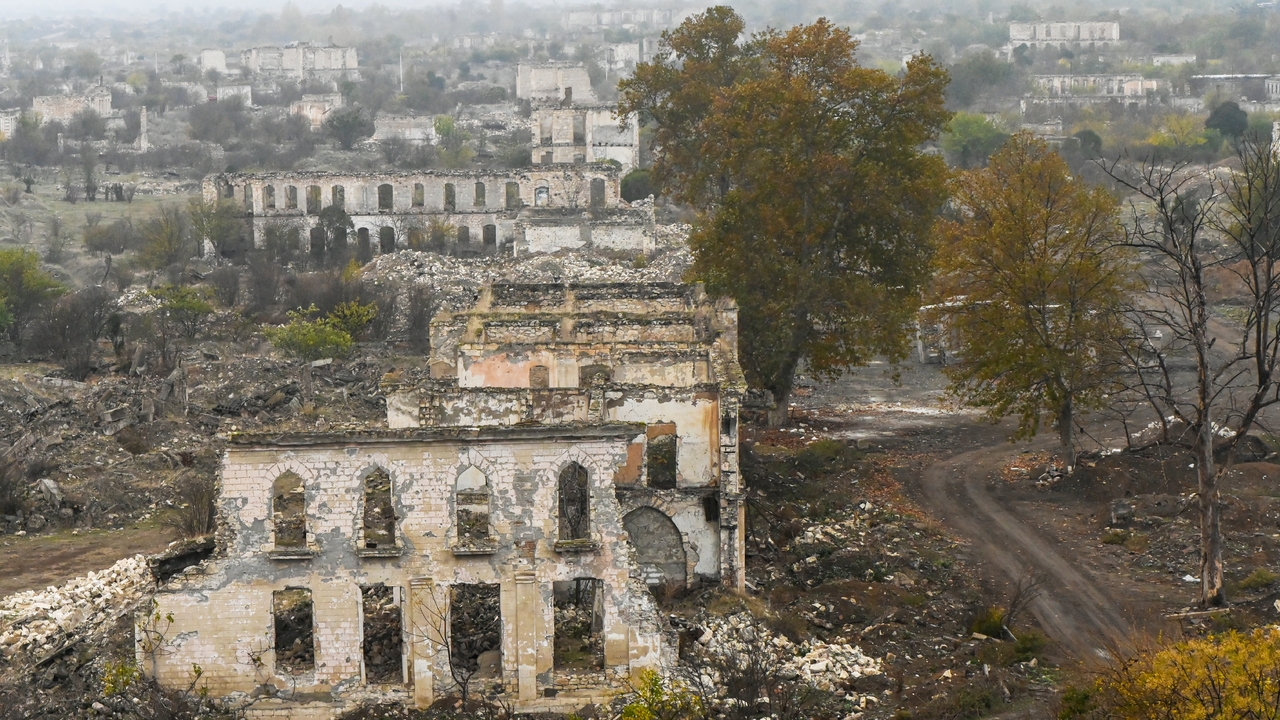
left=144, top=284, right=744, bottom=719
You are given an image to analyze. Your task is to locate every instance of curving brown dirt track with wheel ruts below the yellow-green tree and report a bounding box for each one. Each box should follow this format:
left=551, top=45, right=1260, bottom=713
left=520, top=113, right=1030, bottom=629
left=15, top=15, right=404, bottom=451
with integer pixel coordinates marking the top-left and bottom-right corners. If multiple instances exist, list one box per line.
left=922, top=443, right=1134, bottom=660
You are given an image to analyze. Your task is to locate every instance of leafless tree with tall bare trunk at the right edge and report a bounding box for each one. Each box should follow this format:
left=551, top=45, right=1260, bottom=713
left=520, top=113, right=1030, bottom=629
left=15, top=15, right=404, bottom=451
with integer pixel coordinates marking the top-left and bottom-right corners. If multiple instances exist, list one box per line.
left=1106, top=138, right=1280, bottom=606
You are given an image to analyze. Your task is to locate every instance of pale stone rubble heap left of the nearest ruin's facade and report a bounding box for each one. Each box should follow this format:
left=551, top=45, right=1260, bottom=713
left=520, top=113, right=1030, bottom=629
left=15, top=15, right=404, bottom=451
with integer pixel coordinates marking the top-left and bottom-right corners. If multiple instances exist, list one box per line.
left=0, top=555, right=155, bottom=659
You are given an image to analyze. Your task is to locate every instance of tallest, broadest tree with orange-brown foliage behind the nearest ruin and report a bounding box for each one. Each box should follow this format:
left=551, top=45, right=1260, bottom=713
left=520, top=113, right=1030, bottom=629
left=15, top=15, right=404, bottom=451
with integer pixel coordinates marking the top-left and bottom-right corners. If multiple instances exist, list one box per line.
left=618, top=6, right=950, bottom=424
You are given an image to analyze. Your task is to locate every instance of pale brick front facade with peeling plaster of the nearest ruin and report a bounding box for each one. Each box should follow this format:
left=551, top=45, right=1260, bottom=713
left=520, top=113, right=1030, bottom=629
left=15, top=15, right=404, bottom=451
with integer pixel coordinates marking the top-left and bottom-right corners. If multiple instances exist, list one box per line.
left=148, top=425, right=663, bottom=708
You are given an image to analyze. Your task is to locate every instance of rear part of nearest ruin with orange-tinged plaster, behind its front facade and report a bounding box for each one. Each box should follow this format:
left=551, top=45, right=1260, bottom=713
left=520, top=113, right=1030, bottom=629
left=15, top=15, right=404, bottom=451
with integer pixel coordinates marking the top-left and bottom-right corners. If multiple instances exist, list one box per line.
left=387, top=283, right=745, bottom=587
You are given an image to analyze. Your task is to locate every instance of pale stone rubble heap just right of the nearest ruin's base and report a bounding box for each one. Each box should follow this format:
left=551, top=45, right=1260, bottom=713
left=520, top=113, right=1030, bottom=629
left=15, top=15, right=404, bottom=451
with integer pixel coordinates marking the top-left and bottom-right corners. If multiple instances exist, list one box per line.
left=698, top=612, right=883, bottom=706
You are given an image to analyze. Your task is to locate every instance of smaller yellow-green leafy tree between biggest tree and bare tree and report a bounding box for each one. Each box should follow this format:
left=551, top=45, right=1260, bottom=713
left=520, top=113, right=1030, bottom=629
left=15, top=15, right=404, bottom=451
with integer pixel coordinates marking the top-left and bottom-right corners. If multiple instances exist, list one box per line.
left=936, top=133, right=1137, bottom=468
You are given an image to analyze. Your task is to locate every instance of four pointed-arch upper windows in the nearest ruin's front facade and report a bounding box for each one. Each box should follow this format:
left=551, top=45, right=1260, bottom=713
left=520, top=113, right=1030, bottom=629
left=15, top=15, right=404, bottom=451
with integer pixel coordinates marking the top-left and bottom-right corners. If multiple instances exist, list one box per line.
left=271, top=462, right=591, bottom=551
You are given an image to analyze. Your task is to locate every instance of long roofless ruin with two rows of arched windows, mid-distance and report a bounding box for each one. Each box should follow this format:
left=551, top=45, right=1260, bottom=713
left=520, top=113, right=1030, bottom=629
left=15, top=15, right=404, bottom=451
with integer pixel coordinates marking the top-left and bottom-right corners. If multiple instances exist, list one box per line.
left=204, top=164, right=654, bottom=259
